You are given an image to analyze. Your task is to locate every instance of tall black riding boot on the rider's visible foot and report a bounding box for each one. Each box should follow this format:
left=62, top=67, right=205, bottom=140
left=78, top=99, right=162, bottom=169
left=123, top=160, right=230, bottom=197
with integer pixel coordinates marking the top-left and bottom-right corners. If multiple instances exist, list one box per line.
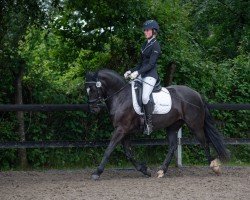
left=143, top=101, right=154, bottom=135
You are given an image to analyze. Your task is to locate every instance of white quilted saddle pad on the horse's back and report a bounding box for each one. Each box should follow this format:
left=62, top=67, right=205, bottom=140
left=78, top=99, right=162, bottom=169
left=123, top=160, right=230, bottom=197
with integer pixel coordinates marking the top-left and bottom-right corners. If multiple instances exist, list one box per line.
left=131, top=81, right=172, bottom=115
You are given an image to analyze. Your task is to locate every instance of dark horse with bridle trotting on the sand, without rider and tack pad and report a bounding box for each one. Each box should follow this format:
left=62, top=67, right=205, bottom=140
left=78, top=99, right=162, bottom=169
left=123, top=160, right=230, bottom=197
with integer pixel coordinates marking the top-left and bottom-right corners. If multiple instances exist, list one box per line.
left=85, top=69, right=230, bottom=180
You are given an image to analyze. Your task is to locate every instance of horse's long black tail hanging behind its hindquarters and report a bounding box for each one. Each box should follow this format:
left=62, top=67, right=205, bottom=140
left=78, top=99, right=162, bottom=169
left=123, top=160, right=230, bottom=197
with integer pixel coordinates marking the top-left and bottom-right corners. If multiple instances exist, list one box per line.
left=203, top=101, right=230, bottom=161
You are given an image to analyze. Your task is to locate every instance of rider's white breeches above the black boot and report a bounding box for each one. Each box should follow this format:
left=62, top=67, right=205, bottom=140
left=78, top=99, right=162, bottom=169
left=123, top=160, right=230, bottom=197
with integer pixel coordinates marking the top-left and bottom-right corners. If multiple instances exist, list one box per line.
left=138, top=75, right=156, bottom=104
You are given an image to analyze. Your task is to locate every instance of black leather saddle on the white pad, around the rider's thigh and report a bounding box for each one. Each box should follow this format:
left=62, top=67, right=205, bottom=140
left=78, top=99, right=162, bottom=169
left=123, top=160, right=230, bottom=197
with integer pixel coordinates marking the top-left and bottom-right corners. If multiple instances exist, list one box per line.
left=134, top=78, right=162, bottom=109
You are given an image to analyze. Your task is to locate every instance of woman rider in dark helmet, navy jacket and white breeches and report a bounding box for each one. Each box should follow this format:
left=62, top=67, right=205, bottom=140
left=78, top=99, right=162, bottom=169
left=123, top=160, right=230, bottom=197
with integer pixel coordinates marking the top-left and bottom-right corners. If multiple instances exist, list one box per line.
left=124, top=20, right=161, bottom=134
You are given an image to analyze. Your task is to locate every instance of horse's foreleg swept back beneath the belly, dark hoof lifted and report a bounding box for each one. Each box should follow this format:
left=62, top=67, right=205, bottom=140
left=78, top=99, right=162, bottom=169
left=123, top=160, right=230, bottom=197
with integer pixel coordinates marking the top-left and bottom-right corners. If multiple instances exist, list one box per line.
left=122, top=137, right=151, bottom=176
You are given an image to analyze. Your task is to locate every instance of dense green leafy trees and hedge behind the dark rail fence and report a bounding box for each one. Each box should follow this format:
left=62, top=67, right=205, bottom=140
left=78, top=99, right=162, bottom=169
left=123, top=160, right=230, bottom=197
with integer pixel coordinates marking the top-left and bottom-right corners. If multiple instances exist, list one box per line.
left=0, top=0, right=250, bottom=170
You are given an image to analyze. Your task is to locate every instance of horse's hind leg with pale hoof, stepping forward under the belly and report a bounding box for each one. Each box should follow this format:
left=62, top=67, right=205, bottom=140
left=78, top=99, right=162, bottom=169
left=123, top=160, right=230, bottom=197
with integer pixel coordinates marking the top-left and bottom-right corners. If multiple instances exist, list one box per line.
left=157, top=120, right=183, bottom=178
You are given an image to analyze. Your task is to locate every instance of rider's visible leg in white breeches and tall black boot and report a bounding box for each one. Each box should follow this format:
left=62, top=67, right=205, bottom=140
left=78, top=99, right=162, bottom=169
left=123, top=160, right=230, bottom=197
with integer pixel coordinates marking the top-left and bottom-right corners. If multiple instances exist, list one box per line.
left=142, top=77, right=156, bottom=134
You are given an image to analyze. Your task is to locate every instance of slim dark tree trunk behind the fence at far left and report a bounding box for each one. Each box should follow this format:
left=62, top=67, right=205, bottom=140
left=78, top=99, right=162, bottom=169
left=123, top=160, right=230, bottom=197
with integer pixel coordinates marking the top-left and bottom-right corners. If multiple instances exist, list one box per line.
left=15, top=63, right=28, bottom=169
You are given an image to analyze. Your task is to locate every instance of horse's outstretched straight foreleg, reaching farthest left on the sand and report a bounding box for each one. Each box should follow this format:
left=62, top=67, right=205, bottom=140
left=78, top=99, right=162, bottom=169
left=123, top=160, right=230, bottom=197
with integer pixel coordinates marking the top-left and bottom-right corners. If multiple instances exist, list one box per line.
left=92, top=127, right=124, bottom=180
